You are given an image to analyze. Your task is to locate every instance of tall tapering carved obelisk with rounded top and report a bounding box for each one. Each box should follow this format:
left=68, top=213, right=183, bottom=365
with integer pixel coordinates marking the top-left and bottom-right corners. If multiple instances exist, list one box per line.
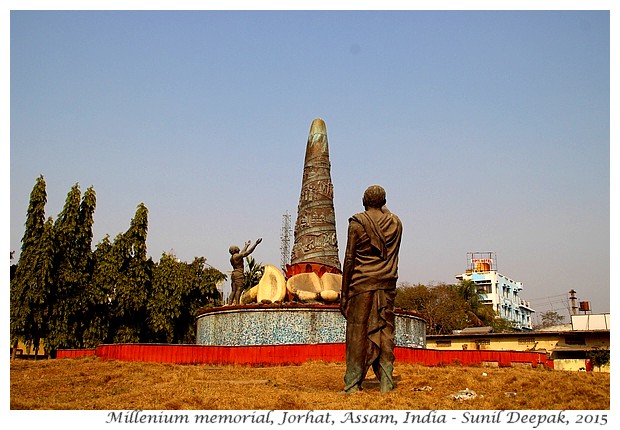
left=287, top=118, right=341, bottom=276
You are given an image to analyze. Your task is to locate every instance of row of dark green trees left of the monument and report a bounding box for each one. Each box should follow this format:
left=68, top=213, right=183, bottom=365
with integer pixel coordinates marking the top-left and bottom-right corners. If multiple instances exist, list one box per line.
left=10, top=176, right=226, bottom=356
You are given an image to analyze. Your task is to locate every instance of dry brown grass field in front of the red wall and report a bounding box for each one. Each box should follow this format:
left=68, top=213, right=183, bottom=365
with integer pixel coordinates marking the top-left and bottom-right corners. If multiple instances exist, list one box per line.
left=10, top=357, right=610, bottom=410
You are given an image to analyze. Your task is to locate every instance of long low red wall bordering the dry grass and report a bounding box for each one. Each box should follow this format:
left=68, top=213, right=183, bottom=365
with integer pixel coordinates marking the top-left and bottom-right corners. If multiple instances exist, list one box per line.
left=56, top=343, right=553, bottom=367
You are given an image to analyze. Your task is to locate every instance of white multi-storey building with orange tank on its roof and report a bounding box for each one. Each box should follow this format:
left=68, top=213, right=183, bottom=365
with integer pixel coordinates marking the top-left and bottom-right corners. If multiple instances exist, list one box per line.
left=456, top=252, right=535, bottom=330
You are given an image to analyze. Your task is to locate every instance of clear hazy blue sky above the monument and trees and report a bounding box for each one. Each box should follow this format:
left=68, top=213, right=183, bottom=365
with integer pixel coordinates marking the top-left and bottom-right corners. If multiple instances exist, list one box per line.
left=10, top=2, right=610, bottom=322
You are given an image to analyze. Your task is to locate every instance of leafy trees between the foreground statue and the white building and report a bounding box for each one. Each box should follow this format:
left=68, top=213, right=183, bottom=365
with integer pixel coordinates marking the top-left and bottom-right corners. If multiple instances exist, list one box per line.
left=395, top=281, right=514, bottom=335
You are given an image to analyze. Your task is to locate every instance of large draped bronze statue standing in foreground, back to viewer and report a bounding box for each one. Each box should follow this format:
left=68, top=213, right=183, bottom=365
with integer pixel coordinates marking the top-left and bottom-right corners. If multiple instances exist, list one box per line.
left=340, top=185, right=403, bottom=393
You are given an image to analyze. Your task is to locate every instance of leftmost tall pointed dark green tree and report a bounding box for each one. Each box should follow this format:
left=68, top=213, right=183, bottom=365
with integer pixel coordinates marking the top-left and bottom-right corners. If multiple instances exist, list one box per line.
left=10, top=176, right=53, bottom=357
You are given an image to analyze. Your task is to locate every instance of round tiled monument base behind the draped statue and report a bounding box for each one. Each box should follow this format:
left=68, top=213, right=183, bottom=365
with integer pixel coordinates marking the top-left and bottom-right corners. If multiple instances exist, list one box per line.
left=196, top=303, right=426, bottom=348
